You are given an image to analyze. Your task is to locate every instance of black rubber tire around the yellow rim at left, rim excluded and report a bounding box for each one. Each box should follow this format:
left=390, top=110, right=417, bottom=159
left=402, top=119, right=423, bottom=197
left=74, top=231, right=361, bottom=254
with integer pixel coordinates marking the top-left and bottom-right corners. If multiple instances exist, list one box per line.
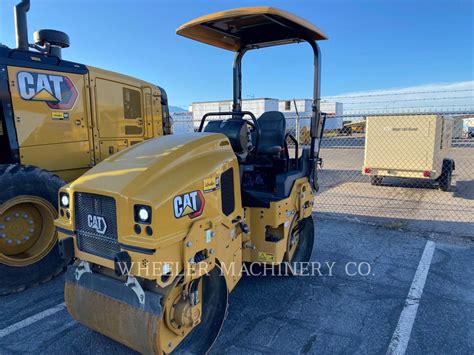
left=0, top=164, right=69, bottom=295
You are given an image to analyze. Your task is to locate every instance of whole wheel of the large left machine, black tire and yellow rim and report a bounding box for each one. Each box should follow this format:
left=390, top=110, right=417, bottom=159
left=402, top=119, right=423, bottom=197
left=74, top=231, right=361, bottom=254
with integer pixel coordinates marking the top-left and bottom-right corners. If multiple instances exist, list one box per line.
left=0, top=164, right=68, bottom=295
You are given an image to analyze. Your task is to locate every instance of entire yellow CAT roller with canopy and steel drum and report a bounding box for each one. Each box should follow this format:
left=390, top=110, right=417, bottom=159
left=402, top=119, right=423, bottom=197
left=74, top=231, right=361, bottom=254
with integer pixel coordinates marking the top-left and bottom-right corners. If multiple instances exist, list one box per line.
left=56, top=7, right=326, bottom=354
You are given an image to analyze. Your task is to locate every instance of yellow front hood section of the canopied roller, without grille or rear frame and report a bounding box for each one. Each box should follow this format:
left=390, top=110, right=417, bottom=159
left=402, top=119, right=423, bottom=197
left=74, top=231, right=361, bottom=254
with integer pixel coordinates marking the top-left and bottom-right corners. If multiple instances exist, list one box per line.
left=57, top=134, right=244, bottom=287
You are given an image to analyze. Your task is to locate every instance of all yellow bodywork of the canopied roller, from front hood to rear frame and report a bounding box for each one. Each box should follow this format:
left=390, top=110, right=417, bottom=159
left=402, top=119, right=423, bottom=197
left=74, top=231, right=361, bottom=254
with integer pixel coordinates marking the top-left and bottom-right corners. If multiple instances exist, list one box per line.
left=56, top=133, right=313, bottom=276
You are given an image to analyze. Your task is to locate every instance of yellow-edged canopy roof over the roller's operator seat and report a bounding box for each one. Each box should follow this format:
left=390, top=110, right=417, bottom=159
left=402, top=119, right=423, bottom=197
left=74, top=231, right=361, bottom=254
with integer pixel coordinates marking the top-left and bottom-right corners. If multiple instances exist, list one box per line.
left=176, top=7, right=327, bottom=52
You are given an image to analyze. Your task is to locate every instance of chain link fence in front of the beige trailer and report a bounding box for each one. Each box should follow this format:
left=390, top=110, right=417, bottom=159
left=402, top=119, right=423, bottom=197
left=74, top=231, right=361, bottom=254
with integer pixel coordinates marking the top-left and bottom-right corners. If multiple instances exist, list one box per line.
left=174, top=113, right=474, bottom=235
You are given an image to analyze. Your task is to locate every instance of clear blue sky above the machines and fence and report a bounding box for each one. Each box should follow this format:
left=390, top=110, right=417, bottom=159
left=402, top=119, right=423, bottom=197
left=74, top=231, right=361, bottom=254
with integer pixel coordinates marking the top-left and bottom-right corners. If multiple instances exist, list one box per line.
left=0, top=0, right=474, bottom=106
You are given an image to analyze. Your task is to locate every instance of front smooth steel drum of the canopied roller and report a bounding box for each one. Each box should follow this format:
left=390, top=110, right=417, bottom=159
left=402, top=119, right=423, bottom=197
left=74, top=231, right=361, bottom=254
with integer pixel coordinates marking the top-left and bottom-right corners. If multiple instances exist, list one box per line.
left=65, top=262, right=228, bottom=354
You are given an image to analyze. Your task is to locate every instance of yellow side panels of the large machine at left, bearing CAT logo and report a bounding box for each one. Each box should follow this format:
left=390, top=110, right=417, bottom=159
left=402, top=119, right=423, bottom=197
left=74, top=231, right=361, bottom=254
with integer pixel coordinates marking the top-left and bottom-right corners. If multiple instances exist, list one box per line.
left=8, top=66, right=170, bottom=181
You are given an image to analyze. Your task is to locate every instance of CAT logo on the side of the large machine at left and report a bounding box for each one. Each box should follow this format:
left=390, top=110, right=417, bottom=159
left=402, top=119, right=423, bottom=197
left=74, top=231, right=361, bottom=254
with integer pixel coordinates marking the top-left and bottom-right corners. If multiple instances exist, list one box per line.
left=17, top=71, right=78, bottom=110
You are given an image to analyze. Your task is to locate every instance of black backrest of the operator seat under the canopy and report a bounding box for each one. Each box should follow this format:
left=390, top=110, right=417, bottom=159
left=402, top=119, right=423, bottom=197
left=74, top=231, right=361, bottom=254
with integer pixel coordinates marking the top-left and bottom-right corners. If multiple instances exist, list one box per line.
left=258, top=111, right=286, bottom=155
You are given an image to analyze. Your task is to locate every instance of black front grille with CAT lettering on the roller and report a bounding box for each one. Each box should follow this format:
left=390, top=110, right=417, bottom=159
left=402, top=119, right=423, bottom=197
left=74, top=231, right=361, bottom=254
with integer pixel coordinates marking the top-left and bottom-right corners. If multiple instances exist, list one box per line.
left=74, top=192, right=120, bottom=260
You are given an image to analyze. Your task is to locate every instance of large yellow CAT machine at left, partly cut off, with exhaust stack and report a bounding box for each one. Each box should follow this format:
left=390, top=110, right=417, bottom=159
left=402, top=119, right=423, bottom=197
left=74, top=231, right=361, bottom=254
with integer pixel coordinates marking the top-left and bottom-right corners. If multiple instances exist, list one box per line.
left=0, top=0, right=171, bottom=295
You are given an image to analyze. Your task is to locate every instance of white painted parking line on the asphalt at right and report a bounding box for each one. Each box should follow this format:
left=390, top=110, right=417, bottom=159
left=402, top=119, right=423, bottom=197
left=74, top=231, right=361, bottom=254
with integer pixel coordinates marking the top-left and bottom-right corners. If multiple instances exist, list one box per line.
left=387, top=240, right=436, bottom=355
